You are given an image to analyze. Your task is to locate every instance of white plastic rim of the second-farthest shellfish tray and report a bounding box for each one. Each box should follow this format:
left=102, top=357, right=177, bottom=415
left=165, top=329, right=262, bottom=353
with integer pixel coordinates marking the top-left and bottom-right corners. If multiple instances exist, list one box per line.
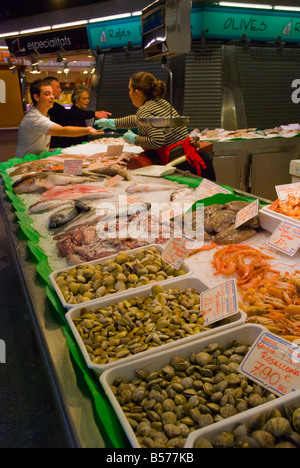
left=66, top=277, right=247, bottom=375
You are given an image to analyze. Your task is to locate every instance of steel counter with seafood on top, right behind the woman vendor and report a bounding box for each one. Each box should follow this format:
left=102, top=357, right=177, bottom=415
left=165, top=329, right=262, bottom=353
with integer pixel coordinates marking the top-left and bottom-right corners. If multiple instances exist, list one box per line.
left=191, top=124, right=300, bottom=200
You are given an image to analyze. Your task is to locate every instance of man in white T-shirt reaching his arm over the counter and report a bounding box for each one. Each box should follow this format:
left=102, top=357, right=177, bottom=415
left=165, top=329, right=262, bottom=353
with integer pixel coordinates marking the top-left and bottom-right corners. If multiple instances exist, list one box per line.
left=15, top=79, right=103, bottom=158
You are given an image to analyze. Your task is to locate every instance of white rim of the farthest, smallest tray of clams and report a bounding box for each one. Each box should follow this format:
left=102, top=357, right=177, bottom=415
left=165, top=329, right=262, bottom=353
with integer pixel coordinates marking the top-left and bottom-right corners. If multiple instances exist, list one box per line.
left=49, top=244, right=192, bottom=309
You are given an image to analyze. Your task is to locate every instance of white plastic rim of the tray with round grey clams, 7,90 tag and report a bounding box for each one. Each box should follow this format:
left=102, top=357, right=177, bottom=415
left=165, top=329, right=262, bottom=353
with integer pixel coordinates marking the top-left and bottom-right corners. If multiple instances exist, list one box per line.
left=100, top=324, right=266, bottom=448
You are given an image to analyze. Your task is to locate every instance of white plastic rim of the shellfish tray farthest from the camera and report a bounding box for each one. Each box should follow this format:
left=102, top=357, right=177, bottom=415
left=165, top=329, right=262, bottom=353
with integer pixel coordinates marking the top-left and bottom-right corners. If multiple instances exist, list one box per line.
left=49, top=244, right=192, bottom=310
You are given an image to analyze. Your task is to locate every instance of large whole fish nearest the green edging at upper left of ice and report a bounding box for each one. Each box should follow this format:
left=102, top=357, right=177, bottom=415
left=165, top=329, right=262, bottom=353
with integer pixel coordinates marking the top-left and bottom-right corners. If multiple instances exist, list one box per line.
left=12, top=172, right=103, bottom=193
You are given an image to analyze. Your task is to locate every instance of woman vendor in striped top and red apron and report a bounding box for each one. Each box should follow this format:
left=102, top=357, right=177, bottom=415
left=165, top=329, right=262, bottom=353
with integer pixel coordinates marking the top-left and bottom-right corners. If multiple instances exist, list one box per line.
left=95, top=72, right=216, bottom=180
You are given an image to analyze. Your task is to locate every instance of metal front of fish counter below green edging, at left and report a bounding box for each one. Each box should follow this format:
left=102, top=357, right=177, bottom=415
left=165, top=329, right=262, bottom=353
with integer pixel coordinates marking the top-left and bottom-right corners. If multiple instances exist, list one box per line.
left=0, top=181, right=127, bottom=448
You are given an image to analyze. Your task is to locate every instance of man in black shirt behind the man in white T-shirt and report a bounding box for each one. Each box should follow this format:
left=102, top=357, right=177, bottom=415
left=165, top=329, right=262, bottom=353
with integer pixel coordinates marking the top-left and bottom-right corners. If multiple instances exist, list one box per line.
left=45, top=76, right=111, bottom=148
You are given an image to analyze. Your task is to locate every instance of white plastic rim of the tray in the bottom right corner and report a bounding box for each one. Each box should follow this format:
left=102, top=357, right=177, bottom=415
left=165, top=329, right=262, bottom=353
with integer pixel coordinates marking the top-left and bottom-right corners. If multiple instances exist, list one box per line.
left=185, top=391, right=300, bottom=448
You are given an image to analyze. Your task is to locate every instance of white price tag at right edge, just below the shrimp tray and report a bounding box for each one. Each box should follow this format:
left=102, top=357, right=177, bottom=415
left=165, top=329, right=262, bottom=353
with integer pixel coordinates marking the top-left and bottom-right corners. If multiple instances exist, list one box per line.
left=267, top=221, right=300, bottom=257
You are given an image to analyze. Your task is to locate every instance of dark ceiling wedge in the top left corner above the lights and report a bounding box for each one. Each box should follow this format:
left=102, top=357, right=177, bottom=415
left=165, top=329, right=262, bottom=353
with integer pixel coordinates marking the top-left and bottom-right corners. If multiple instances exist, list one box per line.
left=0, top=0, right=104, bottom=21
